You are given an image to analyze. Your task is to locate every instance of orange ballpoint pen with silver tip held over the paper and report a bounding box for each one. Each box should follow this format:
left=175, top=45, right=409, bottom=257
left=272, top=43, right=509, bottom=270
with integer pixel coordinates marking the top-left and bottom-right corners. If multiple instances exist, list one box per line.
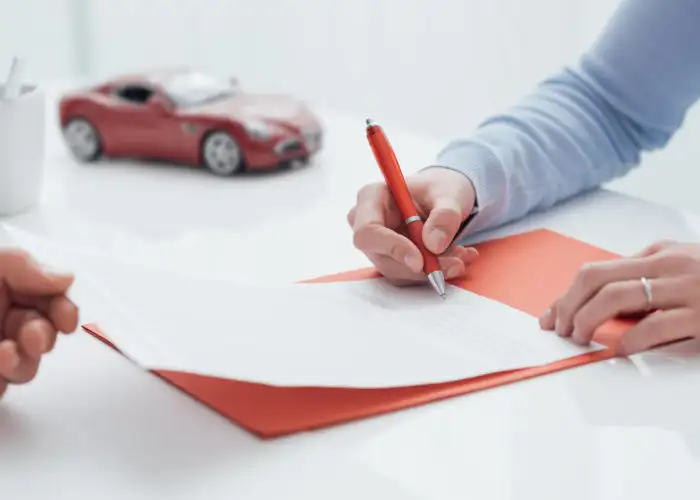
left=367, top=119, right=446, bottom=299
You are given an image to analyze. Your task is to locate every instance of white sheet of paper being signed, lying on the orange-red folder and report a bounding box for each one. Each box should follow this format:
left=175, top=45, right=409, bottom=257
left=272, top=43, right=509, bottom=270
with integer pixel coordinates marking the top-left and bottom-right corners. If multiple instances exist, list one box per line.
left=8, top=227, right=601, bottom=388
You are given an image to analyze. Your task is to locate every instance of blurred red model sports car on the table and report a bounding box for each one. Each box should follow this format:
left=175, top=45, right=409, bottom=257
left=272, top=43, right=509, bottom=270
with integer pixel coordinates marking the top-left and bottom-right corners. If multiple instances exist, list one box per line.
left=59, top=69, right=322, bottom=175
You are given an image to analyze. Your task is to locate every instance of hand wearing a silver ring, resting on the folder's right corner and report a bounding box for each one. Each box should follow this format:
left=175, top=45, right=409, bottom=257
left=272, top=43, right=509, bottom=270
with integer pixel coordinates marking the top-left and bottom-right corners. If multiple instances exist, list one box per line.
left=540, top=241, right=700, bottom=355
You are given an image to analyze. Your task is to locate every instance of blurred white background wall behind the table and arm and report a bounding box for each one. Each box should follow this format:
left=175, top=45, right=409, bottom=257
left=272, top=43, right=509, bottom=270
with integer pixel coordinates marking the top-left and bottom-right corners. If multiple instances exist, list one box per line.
left=0, top=0, right=700, bottom=211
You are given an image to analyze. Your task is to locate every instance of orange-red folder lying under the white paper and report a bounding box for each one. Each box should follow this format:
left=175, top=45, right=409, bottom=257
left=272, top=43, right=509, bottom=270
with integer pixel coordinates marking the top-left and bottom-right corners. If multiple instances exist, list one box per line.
left=83, top=229, right=633, bottom=438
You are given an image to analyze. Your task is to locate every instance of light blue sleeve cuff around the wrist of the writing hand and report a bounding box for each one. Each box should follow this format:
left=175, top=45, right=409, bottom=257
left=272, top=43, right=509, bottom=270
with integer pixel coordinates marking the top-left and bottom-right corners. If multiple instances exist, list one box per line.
left=428, top=141, right=507, bottom=241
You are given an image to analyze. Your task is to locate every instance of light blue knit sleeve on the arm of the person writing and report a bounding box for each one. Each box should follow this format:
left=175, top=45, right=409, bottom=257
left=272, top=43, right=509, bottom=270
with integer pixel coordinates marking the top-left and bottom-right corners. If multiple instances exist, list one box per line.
left=435, top=0, right=700, bottom=238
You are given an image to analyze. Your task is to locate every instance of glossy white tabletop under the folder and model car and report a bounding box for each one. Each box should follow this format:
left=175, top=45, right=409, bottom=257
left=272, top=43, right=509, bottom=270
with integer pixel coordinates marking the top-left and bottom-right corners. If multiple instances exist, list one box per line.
left=0, top=86, right=700, bottom=500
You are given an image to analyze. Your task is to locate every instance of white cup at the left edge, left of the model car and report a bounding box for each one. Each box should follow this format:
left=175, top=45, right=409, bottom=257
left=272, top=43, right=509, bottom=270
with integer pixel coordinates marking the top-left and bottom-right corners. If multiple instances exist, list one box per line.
left=0, top=85, right=46, bottom=216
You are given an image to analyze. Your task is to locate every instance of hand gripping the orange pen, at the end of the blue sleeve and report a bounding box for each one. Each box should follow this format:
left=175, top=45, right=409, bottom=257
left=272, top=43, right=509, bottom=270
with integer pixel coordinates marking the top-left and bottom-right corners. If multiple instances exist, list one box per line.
left=348, top=119, right=478, bottom=294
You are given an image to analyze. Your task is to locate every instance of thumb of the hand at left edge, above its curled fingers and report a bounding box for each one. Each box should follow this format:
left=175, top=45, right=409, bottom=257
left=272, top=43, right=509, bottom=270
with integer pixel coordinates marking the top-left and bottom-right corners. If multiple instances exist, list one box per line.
left=0, top=250, right=73, bottom=295
